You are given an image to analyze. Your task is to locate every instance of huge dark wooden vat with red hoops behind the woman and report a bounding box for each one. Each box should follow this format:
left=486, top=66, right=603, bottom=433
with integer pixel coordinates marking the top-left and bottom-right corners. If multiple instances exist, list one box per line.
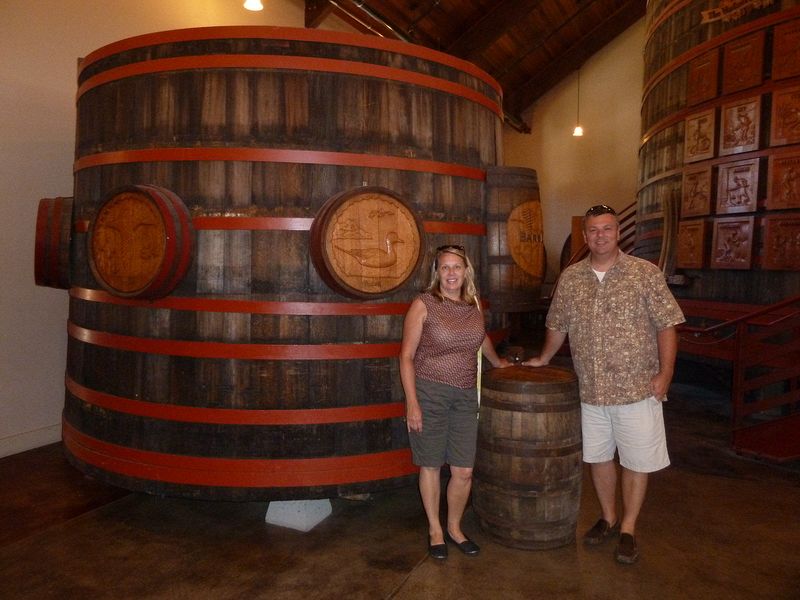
left=63, top=27, right=502, bottom=499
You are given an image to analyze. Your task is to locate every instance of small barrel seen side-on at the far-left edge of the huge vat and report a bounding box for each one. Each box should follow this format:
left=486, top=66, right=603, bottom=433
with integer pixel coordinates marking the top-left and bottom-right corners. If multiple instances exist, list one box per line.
left=33, top=197, right=72, bottom=290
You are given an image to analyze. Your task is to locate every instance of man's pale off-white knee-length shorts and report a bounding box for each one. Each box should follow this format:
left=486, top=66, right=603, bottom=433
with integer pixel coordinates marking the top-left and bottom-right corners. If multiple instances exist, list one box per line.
left=581, top=396, right=669, bottom=473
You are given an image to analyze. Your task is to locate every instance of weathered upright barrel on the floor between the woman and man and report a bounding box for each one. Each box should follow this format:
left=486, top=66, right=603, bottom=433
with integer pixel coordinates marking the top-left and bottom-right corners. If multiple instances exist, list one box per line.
left=472, top=366, right=582, bottom=550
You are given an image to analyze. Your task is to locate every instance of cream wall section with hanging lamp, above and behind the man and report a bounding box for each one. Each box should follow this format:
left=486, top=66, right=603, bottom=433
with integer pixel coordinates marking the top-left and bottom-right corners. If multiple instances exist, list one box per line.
left=504, top=19, right=645, bottom=281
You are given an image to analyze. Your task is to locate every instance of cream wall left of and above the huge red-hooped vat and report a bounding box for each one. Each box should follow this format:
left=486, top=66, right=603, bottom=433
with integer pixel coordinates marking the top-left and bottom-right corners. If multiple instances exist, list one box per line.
left=0, top=0, right=352, bottom=456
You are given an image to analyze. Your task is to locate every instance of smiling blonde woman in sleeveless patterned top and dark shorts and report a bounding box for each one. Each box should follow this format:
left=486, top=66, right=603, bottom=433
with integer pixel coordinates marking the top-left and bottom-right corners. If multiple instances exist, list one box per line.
left=400, top=245, right=511, bottom=559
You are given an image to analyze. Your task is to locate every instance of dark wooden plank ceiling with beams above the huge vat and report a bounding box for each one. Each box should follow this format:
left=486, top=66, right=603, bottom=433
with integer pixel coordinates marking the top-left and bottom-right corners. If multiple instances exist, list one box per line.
left=306, top=0, right=647, bottom=131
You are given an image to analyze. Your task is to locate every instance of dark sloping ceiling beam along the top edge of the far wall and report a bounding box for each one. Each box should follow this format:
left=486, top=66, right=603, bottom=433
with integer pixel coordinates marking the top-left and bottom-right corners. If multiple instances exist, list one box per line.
left=504, top=0, right=646, bottom=114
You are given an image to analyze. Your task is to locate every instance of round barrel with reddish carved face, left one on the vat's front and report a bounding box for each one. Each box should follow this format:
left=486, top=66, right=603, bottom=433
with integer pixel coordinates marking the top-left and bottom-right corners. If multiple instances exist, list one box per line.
left=88, top=185, right=194, bottom=299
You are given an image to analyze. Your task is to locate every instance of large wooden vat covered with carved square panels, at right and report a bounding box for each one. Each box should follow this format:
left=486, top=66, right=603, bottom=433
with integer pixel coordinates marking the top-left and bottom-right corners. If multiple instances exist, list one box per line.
left=634, top=0, right=800, bottom=303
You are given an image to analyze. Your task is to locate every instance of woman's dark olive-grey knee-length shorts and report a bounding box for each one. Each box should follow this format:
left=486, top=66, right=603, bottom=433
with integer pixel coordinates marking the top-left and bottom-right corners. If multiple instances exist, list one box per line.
left=408, top=379, right=478, bottom=468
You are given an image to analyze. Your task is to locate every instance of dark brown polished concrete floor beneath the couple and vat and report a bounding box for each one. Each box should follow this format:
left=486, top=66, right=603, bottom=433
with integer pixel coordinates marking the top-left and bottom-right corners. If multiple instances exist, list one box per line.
left=0, top=385, right=800, bottom=600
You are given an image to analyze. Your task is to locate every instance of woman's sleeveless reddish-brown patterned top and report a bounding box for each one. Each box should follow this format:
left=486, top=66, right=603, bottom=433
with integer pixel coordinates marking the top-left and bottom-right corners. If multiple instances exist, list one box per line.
left=414, top=293, right=486, bottom=388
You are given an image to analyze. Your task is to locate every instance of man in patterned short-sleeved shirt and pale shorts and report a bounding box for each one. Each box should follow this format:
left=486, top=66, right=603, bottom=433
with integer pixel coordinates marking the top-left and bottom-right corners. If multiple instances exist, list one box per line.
left=523, top=204, right=685, bottom=564
